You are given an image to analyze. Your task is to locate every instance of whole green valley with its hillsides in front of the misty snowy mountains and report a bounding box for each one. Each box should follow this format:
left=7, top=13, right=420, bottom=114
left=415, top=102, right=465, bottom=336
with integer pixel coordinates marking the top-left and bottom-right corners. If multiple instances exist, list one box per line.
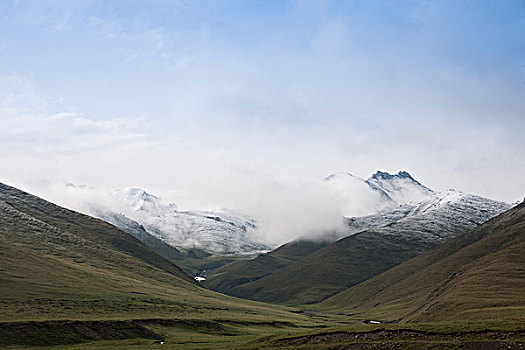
left=0, top=178, right=525, bottom=349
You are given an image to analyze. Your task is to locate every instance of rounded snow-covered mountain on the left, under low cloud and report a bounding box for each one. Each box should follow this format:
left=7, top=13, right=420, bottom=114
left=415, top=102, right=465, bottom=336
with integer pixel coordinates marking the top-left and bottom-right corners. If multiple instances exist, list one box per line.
left=92, top=188, right=269, bottom=254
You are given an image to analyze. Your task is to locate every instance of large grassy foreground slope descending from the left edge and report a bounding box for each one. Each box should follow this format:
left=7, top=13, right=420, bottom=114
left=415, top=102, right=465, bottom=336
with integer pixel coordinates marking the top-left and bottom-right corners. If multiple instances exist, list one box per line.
left=0, top=185, right=320, bottom=343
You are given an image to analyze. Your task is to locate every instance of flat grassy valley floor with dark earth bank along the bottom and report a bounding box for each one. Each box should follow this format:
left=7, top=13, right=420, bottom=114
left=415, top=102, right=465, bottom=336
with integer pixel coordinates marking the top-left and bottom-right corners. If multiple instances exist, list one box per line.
left=0, top=319, right=525, bottom=350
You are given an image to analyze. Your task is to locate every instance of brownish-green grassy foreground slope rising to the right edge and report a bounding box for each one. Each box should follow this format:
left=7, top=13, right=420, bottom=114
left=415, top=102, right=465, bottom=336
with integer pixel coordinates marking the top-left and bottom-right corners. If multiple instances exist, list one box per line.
left=319, top=203, right=525, bottom=322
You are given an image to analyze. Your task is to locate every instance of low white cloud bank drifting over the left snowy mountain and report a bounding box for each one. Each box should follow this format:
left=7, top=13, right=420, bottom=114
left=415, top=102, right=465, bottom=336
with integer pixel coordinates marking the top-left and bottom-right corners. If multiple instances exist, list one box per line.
left=0, top=76, right=352, bottom=244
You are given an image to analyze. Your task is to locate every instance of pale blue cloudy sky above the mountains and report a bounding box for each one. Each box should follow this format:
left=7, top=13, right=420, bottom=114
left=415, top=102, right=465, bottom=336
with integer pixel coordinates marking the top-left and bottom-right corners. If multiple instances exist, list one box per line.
left=0, top=0, right=525, bottom=241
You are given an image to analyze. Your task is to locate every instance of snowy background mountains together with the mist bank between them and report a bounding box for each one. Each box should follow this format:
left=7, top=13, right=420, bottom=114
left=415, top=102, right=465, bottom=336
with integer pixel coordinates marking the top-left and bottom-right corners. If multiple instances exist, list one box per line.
left=19, top=171, right=508, bottom=256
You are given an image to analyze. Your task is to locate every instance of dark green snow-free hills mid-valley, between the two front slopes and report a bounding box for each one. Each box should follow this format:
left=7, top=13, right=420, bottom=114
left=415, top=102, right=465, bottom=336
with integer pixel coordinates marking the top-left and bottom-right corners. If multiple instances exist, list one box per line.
left=207, top=223, right=454, bottom=305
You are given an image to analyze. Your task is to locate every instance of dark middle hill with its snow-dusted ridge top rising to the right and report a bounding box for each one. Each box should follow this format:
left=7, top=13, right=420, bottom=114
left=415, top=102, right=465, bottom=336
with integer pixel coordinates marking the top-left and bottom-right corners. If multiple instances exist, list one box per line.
left=207, top=186, right=511, bottom=305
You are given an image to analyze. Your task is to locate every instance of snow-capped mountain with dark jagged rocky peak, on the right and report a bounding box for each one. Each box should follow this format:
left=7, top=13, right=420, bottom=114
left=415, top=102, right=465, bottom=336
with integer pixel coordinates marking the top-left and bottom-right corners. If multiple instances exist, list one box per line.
left=326, top=171, right=511, bottom=241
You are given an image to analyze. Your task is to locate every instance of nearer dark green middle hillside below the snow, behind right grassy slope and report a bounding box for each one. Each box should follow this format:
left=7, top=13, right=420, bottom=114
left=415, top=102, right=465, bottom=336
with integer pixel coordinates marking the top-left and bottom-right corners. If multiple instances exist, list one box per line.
left=219, top=230, right=434, bottom=305
